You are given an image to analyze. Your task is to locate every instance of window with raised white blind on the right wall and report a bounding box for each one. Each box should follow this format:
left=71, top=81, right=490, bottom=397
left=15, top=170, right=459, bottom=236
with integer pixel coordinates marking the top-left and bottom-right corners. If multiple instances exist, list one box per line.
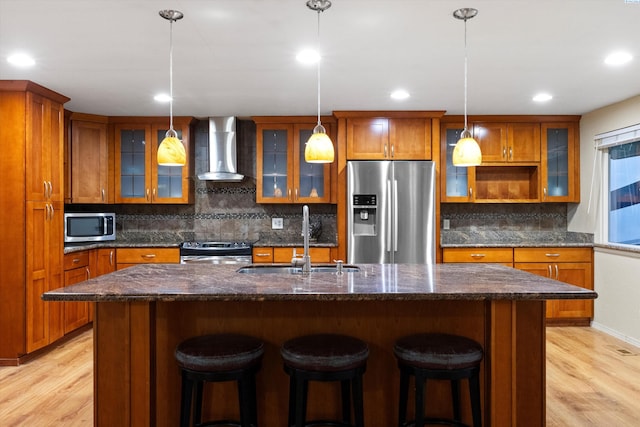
left=595, top=125, right=640, bottom=246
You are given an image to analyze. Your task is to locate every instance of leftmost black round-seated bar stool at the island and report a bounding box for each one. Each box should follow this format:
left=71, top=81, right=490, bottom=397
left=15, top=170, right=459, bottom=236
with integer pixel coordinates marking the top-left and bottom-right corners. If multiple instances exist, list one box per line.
left=175, top=334, right=264, bottom=427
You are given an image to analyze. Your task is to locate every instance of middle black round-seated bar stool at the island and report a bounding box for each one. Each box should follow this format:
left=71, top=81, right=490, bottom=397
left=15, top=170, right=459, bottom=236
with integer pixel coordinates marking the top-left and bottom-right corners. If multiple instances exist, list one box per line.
left=280, top=334, right=369, bottom=427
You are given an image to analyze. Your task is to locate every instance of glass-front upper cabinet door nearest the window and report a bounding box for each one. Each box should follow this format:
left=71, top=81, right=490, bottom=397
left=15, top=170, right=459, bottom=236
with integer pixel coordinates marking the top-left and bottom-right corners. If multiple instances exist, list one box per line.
left=541, top=123, right=579, bottom=202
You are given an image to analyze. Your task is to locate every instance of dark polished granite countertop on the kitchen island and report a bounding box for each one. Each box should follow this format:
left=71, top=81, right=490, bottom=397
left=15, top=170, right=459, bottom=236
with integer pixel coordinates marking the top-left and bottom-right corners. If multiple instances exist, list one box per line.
left=43, top=264, right=597, bottom=302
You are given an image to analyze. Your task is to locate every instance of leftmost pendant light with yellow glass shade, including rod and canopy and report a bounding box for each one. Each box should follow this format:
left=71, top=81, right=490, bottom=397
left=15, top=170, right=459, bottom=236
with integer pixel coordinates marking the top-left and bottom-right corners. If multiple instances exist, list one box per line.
left=158, top=10, right=187, bottom=166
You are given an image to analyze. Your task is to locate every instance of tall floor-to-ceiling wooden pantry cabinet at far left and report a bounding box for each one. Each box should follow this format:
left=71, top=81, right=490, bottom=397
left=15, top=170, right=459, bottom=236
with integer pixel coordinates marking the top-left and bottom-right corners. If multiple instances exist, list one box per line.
left=0, top=80, right=69, bottom=365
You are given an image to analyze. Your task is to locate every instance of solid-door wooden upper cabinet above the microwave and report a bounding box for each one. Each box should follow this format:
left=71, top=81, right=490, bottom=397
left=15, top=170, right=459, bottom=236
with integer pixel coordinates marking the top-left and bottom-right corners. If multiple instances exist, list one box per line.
left=66, top=113, right=113, bottom=203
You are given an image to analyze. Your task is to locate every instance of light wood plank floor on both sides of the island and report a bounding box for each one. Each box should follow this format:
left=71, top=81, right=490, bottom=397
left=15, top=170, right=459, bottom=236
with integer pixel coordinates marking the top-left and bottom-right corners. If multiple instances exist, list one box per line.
left=0, top=327, right=640, bottom=427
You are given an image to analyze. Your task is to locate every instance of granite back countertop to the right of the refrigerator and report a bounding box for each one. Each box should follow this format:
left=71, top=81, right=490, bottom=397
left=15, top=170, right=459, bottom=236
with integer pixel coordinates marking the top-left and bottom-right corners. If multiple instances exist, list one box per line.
left=440, top=230, right=594, bottom=248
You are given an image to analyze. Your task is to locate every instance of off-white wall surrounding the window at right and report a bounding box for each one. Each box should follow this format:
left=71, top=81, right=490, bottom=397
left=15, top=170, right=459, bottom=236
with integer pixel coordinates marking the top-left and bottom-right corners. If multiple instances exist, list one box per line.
left=568, top=96, right=640, bottom=345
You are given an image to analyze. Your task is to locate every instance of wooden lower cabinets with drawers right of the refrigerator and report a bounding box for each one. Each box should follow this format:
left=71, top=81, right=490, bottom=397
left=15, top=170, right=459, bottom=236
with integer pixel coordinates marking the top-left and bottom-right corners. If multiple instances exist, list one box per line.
left=442, top=247, right=593, bottom=326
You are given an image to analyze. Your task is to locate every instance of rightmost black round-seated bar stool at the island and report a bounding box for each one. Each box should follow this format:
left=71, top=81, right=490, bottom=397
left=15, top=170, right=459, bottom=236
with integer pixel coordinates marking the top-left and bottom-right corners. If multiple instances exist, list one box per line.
left=393, top=334, right=483, bottom=427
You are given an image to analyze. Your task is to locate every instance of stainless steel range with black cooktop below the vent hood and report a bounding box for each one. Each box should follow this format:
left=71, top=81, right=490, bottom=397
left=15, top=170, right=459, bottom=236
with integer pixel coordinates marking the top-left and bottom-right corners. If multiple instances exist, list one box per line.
left=180, top=242, right=252, bottom=264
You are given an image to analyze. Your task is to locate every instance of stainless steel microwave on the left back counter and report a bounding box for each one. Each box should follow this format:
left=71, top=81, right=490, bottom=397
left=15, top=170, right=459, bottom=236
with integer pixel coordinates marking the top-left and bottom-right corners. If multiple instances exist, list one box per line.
left=64, top=212, right=116, bottom=243
